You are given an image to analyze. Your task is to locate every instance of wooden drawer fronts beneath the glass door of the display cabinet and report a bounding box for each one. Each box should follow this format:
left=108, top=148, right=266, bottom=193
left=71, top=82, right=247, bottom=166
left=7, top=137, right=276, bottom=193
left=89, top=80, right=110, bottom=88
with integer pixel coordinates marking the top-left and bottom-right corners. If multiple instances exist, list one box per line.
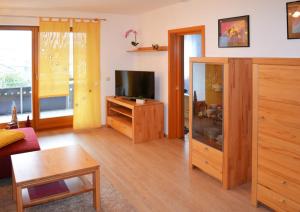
left=191, top=141, right=223, bottom=182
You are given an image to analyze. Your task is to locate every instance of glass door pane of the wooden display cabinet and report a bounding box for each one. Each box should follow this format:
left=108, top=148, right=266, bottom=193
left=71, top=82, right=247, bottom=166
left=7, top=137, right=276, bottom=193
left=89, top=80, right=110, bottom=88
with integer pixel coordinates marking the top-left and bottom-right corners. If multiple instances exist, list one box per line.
left=192, top=63, right=224, bottom=151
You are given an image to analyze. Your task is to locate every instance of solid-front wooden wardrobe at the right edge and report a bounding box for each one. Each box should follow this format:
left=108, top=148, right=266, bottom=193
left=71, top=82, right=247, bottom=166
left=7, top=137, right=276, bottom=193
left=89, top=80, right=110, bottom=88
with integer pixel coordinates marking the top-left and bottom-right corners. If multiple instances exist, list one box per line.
left=252, top=58, right=300, bottom=212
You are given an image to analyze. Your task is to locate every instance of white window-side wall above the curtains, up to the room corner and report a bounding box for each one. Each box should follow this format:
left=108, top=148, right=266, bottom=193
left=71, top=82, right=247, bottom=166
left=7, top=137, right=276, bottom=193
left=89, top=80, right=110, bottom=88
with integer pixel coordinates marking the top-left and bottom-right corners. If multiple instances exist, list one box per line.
left=0, top=9, right=137, bottom=124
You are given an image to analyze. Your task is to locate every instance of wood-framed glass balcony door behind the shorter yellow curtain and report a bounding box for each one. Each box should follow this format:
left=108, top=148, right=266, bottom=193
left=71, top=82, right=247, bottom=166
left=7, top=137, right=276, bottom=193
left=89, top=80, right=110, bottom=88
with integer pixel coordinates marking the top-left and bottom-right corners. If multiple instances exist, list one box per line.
left=0, top=26, right=73, bottom=129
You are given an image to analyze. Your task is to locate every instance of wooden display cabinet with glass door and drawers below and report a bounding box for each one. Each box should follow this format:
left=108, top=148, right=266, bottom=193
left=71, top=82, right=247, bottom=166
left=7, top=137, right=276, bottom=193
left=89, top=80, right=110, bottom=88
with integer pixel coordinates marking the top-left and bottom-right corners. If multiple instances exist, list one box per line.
left=189, top=58, right=252, bottom=188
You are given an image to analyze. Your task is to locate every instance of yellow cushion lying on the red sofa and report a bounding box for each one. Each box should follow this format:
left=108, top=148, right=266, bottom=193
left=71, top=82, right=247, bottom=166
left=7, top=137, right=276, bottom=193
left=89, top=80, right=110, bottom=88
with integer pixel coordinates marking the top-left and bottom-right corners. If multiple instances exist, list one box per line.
left=0, top=129, right=25, bottom=149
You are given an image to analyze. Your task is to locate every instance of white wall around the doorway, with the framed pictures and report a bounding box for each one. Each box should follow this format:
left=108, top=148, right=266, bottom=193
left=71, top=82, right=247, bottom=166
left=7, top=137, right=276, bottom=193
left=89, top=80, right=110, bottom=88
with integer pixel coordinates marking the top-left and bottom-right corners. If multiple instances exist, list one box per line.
left=135, top=0, right=300, bottom=132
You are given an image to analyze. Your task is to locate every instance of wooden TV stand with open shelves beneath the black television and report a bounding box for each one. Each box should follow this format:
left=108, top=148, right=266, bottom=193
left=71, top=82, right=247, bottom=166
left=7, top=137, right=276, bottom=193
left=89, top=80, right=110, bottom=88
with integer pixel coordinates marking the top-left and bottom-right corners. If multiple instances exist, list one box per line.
left=106, top=96, right=164, bottom=143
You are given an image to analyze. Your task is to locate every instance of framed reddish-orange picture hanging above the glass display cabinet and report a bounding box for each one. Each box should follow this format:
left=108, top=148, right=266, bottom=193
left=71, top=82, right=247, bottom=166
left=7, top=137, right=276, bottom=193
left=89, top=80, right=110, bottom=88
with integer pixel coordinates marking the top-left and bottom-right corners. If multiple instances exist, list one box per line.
left=218, top=15, right=250, bottom=48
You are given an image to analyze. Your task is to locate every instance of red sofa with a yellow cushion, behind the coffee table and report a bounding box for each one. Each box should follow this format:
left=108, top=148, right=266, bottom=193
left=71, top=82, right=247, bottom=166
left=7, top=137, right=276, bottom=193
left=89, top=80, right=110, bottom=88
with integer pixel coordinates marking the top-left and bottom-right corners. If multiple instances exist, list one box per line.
left=0, top=128, right=40, bottom=179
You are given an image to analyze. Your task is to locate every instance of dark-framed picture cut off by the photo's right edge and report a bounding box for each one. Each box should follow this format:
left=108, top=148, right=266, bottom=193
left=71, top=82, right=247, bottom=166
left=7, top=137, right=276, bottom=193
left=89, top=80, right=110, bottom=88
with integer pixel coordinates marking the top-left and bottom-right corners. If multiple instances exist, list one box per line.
left=286, top=1, right=300, bottom=39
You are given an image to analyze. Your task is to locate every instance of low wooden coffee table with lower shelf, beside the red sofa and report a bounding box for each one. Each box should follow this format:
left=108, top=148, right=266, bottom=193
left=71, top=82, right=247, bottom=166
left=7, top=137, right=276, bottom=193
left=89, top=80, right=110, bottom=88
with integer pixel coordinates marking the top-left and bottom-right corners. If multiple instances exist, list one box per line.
left=11, top=145, right=100, bottom=212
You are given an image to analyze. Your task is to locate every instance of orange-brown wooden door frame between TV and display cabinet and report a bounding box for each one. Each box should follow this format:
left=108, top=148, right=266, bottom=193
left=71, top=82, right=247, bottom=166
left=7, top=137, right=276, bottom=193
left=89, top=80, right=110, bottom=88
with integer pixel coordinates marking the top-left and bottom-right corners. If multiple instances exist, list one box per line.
left=168, top=25, right=205, bottom=139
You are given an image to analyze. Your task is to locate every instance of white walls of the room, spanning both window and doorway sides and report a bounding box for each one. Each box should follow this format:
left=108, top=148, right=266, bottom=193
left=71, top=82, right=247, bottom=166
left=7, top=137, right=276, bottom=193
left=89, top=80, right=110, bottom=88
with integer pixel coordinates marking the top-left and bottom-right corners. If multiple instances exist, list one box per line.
left=0, top=0, right=300, bottom=132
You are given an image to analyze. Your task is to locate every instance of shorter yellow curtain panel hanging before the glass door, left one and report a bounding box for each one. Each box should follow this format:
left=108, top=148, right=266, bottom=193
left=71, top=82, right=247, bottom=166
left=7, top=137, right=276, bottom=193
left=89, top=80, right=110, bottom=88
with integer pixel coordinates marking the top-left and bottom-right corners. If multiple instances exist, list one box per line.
left=38, top=20, right=70, bottom=98
